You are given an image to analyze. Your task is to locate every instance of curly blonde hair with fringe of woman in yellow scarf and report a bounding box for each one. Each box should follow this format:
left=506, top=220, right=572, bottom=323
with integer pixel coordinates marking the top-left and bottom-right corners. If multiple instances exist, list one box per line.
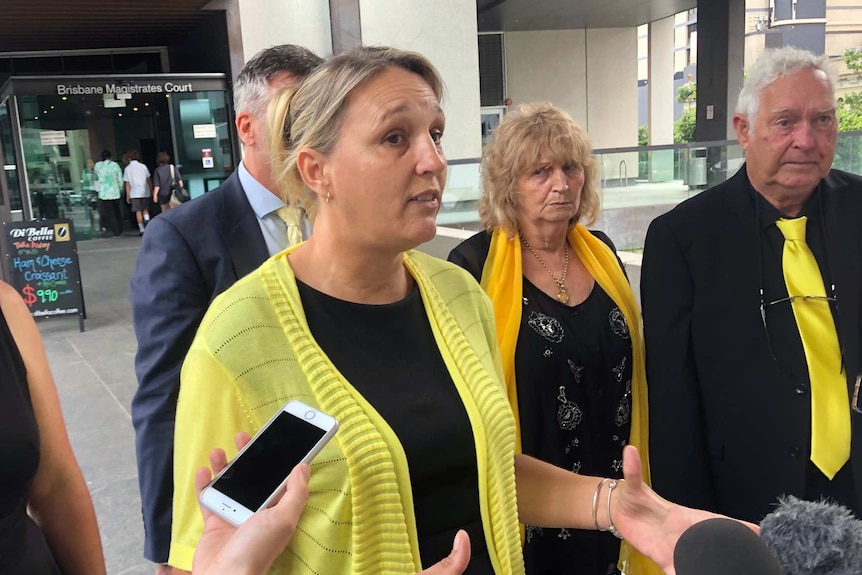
left=479, top=103, right=599, bottom=237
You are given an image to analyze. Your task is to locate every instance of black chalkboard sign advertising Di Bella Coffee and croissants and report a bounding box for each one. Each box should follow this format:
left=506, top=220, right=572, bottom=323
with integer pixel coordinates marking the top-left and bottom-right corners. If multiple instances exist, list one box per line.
left=4, top=220, right=86, bottom=331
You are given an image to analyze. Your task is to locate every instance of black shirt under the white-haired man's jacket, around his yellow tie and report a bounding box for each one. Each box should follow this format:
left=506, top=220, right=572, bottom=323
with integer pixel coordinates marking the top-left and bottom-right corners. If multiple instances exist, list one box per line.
left=749, top=183, right=860, bottom=512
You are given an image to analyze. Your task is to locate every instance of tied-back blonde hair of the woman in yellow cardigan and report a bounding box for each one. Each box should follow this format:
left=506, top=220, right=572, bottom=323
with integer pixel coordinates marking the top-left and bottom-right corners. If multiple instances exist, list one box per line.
left=267, top=46, right=443, bottom=219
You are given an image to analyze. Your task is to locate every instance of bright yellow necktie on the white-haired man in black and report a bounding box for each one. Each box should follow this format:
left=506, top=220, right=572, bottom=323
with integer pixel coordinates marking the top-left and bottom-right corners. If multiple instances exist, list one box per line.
left=775, top=216, right=850, bottom=479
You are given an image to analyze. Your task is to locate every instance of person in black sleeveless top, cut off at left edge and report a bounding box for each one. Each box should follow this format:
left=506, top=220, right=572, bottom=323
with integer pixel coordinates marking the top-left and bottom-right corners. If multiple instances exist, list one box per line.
left=0, top=282, right=105, bottom=575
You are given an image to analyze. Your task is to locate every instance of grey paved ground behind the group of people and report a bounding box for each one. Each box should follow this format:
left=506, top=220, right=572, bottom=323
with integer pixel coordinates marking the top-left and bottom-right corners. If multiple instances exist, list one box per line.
left=44, top=231, right=639, bottom=575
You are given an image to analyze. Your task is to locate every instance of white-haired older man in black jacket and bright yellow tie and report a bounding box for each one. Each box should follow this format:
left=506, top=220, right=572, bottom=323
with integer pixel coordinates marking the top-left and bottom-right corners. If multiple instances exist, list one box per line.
left=641, top=48, right=862, bottom=521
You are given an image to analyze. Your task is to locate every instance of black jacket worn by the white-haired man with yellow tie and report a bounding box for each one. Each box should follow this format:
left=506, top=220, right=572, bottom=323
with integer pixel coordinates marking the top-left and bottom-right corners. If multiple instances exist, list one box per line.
left=641, top=167, right=862, bottom=521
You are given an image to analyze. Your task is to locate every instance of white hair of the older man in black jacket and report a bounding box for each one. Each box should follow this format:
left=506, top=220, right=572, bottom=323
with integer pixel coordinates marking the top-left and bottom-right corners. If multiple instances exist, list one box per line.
left=736, top=46, right=837, bottom=127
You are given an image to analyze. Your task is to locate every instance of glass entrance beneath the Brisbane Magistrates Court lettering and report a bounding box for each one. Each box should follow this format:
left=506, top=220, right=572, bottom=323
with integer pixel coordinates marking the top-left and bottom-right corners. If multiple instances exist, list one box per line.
left=11, top=82, right=234, bottom=240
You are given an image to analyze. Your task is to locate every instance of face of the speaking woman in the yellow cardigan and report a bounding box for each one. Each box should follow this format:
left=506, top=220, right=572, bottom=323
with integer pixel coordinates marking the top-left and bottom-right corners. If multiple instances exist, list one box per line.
left=319, top=68, right=446, bottom=252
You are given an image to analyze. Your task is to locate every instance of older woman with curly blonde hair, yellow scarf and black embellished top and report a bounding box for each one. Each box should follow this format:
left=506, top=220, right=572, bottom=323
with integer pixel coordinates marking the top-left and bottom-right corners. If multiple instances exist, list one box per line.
left=449, top=104, right=660, bottom=575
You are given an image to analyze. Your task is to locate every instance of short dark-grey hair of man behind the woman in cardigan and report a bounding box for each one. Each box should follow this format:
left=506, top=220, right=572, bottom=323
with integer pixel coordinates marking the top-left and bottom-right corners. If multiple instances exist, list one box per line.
left=233, top=44, right=323, bottom=118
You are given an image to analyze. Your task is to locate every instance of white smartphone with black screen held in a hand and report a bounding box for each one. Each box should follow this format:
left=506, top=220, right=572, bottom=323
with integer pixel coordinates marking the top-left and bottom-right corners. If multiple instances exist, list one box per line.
left=200, top=401, right=338, bottom=526
